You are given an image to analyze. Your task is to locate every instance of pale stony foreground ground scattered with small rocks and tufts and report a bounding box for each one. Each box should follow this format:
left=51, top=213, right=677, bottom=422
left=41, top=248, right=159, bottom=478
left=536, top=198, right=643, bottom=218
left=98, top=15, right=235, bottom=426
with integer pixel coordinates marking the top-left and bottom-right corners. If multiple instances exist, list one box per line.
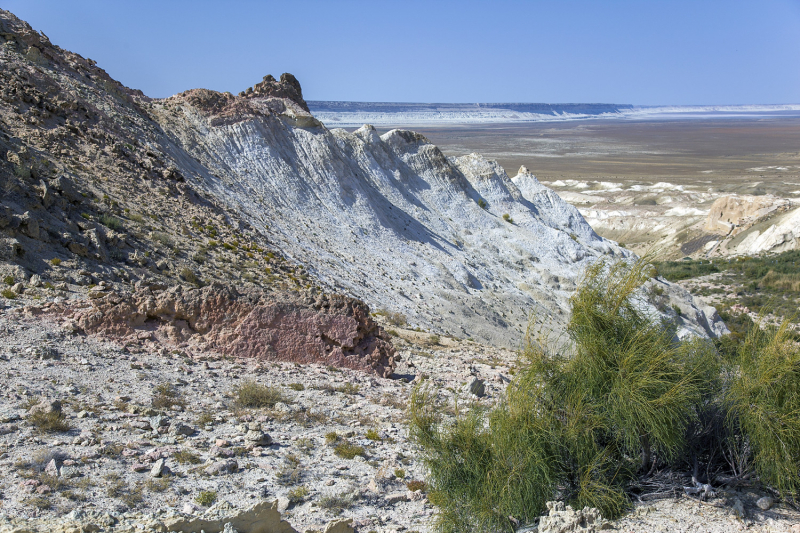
left=0, top=290, right=800, bottom=533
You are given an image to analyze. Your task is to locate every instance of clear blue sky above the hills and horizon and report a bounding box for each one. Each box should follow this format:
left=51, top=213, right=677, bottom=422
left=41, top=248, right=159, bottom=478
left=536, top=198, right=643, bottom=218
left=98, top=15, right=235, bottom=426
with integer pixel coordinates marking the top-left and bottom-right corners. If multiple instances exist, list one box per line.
left=2, top=0, right=800, bottom=105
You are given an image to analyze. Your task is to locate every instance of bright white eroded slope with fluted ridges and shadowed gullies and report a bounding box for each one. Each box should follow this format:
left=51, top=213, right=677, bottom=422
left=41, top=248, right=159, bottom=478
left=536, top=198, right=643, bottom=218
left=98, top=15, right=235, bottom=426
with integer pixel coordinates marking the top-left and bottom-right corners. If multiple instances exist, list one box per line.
left=155, top=101, right=724, bottom=347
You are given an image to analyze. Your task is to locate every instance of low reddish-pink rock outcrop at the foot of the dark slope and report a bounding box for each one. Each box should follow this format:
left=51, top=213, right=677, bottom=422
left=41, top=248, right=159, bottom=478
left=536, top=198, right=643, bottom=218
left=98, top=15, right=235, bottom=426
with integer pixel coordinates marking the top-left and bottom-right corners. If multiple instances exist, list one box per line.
left=48, top=284, right=398, bottom=377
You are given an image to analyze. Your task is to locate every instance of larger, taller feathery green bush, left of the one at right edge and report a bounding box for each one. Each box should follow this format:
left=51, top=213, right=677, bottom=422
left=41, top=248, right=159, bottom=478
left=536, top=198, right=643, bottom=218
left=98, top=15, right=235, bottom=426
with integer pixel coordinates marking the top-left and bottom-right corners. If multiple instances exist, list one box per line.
left=409, top=261, right=715, bottom=532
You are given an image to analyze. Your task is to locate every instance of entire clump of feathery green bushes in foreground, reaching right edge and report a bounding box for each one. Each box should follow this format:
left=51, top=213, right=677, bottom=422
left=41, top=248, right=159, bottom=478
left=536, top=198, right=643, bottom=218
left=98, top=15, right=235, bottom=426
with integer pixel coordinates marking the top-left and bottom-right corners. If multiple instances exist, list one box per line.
left=409, top=258, right=800, bottom=533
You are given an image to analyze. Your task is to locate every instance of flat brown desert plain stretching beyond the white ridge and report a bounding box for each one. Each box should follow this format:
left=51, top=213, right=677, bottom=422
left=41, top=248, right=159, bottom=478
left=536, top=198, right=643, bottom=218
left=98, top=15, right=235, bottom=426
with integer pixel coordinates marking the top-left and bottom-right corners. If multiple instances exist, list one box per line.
left=380, top=116, right=800, bottom=197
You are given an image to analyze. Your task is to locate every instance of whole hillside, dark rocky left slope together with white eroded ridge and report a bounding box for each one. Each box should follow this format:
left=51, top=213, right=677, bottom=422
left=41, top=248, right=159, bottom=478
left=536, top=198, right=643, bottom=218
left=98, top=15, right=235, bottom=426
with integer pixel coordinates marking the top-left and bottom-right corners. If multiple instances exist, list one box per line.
left=0, top=11, right=724, bottom=350
